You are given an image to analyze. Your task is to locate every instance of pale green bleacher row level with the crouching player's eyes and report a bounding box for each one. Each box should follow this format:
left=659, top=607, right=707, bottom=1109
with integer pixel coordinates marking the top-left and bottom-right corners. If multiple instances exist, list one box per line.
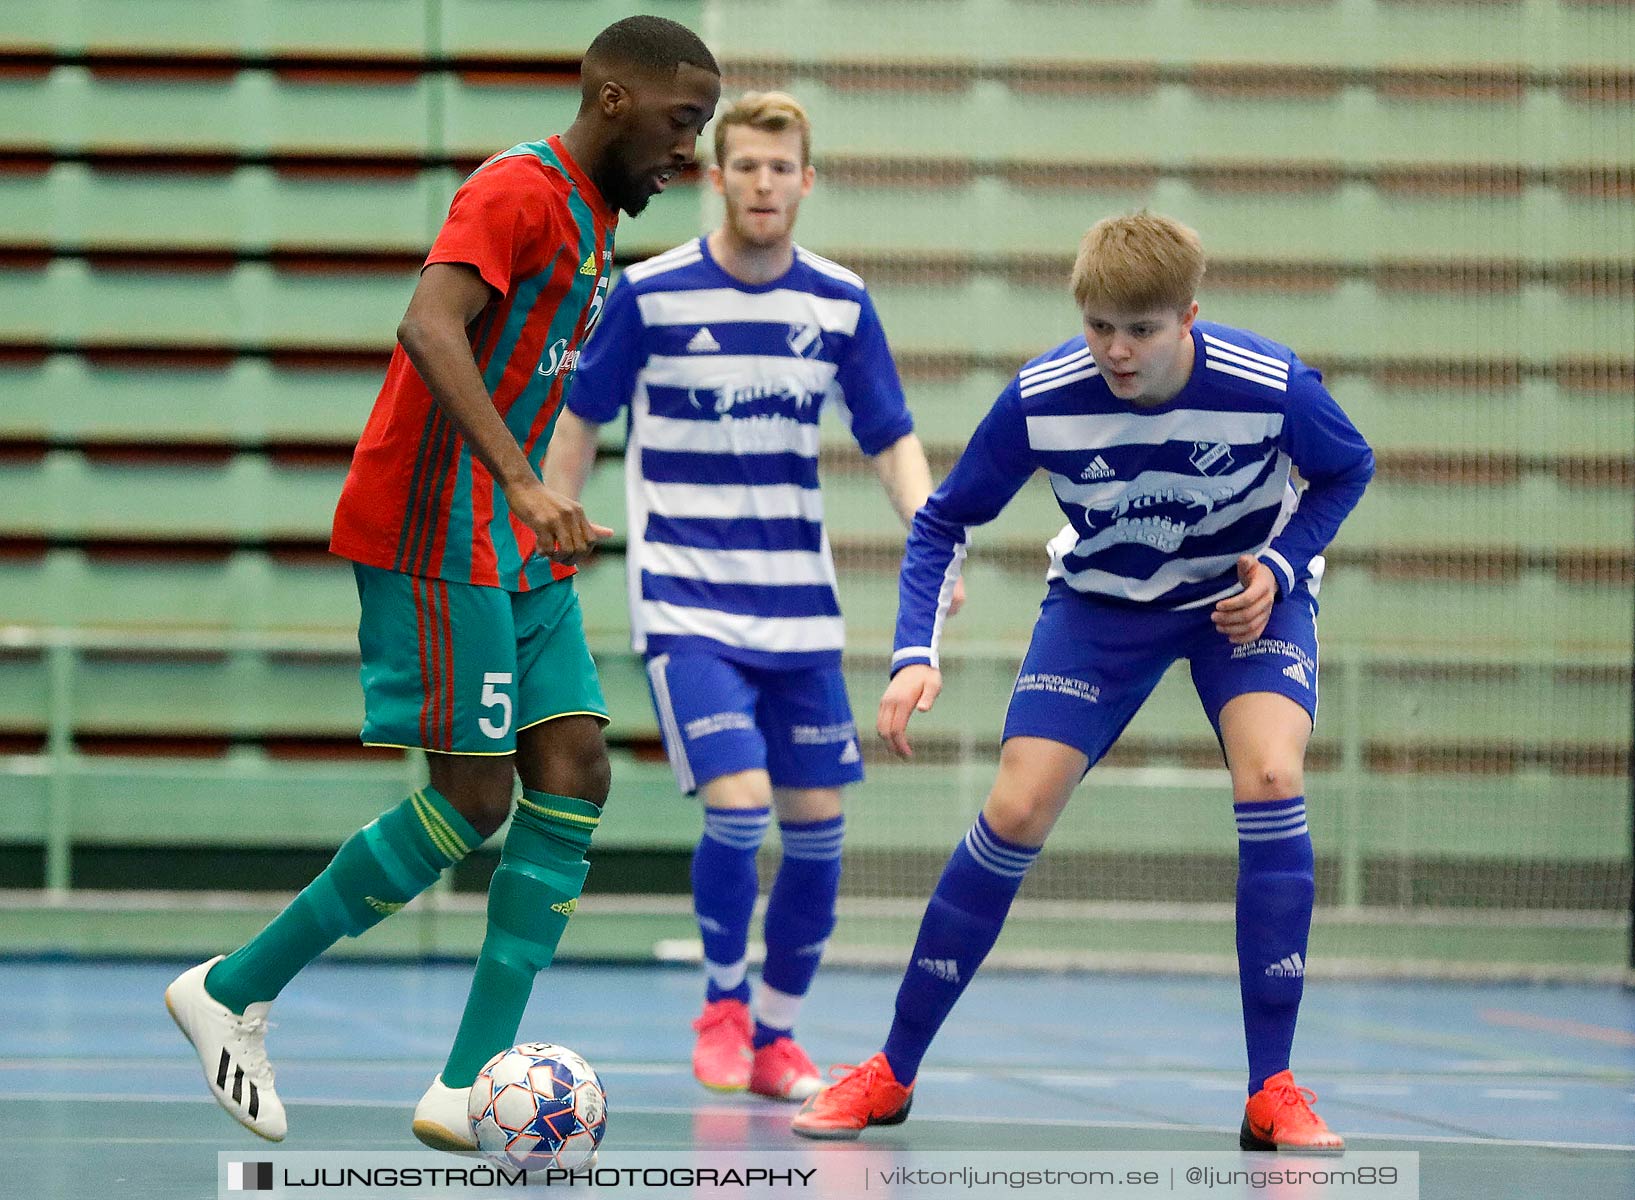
left=9, top=258, right=1628, bottom=363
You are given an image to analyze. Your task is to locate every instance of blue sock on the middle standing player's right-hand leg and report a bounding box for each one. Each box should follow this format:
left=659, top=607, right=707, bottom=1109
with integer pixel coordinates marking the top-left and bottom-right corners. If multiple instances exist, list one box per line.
left=755, top=816, right=845, bottom=1050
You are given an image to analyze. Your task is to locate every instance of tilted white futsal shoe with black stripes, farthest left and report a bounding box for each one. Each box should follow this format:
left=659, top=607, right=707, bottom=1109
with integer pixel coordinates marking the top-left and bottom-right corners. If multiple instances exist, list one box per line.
left=165, top=955, right=289, bottom=1141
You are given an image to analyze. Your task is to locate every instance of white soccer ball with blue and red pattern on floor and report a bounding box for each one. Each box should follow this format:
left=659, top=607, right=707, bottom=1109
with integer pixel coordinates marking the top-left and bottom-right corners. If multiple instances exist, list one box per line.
left=466, top=1041, right=608, bottom=1171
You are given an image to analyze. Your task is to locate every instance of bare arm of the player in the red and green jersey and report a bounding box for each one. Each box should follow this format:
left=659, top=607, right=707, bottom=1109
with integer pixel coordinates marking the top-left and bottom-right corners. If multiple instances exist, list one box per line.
left=397, top=262, right=613, bottom=561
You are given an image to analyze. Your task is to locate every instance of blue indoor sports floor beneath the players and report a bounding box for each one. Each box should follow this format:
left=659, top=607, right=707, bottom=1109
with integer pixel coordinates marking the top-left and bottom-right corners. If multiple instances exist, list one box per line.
left=0, top=961, right=1635, bottom=1200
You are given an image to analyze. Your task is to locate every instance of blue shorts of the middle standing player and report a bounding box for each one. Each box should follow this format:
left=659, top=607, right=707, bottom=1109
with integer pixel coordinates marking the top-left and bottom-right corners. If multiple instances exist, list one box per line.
left=647, top=651, right=863, bottom=795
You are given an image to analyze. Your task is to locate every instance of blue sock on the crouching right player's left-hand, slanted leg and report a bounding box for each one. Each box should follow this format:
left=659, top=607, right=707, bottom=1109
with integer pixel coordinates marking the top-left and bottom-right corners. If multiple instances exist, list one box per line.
left=885, top=814, right=1040, bottom=1084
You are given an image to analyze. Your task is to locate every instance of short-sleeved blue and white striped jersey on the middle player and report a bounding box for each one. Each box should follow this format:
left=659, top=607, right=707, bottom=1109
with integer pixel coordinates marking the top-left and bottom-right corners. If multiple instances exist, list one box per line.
left=567, top=239, right=914, bottom=667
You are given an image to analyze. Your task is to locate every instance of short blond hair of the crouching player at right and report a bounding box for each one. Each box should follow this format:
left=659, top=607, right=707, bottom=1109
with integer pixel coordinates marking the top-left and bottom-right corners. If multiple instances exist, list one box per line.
left=1071, top=209, right=1205, bottom=314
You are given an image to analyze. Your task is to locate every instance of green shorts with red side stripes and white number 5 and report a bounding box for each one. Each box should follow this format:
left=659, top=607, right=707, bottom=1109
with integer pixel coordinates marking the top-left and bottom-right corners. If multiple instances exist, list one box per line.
left=353, top=562, right=608, bottom=754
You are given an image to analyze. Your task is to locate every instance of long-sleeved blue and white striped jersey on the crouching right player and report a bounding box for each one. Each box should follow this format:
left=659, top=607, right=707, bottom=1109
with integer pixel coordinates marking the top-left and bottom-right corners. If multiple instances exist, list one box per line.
left=891, top=320, right=1373, bottom=670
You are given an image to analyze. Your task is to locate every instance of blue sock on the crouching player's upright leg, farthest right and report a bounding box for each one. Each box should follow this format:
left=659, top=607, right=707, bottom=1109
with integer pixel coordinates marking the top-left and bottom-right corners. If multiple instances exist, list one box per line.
left=1233, top=796, right=1316, bottom=1095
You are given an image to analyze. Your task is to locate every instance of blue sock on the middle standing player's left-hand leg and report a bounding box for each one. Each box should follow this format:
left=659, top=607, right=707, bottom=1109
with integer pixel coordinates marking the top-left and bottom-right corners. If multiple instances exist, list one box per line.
left=693, top=808, right=772, bottom=1004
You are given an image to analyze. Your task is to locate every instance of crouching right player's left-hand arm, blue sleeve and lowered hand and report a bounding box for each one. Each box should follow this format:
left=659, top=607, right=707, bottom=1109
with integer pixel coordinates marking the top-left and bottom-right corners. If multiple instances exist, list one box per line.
left=875, top=383, right=1033, bottom=759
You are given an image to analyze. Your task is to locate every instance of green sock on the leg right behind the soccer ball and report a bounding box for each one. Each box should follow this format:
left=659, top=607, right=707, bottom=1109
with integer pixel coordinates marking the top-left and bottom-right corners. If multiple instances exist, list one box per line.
left=443, top=788, right=602, bottom=1087
